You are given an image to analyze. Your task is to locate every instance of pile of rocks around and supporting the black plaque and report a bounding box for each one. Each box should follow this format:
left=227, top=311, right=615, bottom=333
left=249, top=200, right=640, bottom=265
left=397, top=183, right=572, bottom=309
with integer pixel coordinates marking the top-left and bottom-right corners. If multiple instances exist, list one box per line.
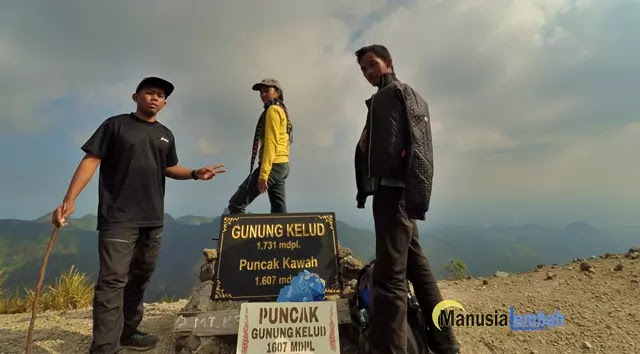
left=174, top=246, right=363, bottom=354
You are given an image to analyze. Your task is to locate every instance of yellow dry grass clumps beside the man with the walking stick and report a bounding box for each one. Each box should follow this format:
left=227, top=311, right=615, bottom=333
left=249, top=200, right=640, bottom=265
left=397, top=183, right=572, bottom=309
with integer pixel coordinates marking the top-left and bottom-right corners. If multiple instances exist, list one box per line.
left=0, top=266, right=93, bottom=314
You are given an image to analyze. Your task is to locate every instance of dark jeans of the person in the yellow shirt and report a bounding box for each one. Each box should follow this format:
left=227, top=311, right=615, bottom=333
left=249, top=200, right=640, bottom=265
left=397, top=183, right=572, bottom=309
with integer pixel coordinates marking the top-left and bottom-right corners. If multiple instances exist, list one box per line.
left=228, top=162, right=289, bottom=214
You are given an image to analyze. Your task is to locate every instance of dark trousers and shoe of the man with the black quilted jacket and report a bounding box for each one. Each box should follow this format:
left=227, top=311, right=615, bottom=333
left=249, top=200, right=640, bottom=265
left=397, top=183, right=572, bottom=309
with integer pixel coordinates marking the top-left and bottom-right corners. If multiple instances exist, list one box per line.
left=370, top=186, right=459, bottom=354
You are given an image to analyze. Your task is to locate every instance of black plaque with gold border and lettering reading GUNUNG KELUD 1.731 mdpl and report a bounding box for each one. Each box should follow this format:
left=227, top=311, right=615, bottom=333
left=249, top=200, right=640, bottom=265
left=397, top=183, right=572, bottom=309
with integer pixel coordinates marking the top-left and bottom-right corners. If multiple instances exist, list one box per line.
left=211, top=213, right=342, bottom=301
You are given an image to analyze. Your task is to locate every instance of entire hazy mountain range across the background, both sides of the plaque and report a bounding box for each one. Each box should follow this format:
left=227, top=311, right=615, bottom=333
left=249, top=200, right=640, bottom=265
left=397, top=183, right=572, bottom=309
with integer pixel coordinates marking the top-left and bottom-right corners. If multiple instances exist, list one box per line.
left=0, top=214, right=640, bottom=301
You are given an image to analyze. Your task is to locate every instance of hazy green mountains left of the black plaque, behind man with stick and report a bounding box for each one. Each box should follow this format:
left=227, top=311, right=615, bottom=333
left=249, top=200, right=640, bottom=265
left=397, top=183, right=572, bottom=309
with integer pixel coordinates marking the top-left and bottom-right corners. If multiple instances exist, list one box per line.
left=0, top=213, right=225, bottom=301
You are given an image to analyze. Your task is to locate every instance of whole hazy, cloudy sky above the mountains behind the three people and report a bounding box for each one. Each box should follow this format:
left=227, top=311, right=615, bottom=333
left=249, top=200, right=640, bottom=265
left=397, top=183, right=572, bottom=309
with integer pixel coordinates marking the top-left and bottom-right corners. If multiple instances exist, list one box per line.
left=0, top=0, right=640, bottom=230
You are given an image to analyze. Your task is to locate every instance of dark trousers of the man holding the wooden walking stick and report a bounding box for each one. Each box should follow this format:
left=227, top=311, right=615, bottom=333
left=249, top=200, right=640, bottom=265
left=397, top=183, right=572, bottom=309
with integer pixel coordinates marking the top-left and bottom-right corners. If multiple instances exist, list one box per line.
left=90, top=227, right=163, bottom=354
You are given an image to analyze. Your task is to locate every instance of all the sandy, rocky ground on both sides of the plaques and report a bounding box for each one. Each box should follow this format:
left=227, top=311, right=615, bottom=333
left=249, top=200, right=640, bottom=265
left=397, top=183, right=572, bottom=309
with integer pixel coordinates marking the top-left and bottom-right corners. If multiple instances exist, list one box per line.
left=0, top=248, right=640, bottom=354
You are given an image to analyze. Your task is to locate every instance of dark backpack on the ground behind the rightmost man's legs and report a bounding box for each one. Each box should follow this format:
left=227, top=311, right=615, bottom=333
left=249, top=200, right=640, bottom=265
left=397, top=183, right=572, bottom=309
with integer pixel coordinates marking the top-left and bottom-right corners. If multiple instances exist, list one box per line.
left=351, top=260, right=431, bottom=354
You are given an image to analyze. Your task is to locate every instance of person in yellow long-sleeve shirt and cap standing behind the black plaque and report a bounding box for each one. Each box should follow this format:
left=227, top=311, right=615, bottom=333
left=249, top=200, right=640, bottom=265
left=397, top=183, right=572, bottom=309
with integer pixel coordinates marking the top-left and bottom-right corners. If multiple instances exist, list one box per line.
left=227, top=78, right=292, bottom=214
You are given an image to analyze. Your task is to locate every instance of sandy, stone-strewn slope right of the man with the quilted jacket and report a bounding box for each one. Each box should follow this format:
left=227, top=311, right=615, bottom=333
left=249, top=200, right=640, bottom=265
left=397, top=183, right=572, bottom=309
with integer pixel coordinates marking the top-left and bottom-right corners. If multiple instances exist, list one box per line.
left=441, top=250, right=640, bottom=354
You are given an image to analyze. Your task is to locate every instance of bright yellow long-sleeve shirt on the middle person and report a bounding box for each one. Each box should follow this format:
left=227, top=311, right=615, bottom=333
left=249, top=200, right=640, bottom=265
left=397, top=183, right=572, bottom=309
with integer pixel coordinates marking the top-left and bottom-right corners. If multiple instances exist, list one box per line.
left=258, top=105, right=289, bottom=180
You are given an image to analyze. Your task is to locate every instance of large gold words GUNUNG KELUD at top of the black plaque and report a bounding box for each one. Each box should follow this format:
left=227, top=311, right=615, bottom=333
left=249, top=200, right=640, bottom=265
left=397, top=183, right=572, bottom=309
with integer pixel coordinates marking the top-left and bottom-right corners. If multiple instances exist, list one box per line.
left=231, top=223, right=326, bottom=239
